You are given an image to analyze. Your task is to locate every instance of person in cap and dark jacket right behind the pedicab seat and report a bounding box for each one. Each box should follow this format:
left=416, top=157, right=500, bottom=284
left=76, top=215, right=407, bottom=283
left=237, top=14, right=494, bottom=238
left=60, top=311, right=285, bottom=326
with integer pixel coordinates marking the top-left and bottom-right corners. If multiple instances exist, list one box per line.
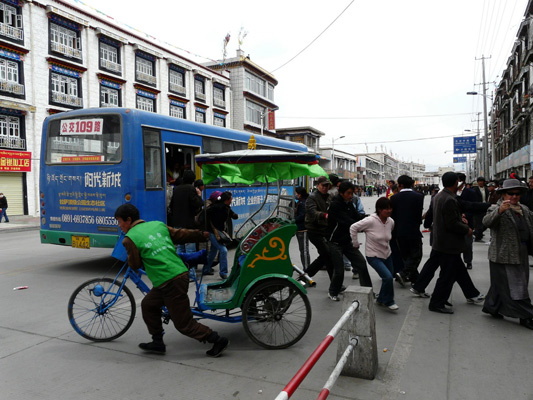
left=305, top=176, right=333, bottom=282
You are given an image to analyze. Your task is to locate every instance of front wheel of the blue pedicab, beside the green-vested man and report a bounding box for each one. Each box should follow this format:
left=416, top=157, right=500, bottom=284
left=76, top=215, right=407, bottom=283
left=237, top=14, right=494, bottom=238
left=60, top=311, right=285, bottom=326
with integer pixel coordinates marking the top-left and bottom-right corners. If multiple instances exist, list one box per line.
left=68, top=278, right=136, bottom=342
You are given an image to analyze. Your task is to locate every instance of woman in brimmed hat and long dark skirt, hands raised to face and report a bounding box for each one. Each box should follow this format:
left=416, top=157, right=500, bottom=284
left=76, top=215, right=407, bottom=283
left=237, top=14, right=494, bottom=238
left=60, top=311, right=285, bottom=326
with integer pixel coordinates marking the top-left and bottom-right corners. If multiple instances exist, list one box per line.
left=482, top=179, right=533, bottom=329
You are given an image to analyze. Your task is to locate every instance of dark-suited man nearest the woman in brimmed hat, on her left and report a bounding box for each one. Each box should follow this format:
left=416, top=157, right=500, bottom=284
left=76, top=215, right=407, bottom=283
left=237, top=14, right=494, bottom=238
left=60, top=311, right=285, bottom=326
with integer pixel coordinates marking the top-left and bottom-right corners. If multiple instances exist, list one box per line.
left=429, top=172, right=472, bottom=314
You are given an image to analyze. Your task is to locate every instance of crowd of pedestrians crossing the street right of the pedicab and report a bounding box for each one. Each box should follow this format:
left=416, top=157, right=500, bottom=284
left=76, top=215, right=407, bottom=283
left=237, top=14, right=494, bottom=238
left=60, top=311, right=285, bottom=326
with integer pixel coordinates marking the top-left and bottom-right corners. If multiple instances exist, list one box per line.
left=297, top=172, right=533, bottom=329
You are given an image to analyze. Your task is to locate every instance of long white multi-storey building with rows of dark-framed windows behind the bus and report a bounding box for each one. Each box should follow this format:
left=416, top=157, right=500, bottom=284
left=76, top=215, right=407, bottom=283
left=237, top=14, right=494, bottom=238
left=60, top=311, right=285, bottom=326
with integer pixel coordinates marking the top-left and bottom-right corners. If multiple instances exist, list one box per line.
left=0, top=0, right=232, bottom=215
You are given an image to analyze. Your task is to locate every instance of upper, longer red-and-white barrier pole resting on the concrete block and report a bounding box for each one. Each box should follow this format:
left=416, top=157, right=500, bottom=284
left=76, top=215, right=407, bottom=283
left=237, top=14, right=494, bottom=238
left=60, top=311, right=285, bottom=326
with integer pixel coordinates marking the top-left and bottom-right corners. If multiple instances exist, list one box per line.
left=275, top=300, right=359, bottom=400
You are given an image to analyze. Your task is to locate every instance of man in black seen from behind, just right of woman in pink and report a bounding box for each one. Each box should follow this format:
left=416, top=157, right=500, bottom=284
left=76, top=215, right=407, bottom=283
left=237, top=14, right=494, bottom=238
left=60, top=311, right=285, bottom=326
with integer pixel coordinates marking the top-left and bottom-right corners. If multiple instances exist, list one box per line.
left=390, top=175, right=424, bottom=286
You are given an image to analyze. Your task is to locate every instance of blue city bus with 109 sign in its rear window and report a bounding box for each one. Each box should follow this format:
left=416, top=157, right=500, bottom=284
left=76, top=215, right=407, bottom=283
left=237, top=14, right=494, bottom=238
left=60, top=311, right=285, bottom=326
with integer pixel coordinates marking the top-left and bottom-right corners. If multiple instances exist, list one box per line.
left=39, top=108, right=308, bottom=249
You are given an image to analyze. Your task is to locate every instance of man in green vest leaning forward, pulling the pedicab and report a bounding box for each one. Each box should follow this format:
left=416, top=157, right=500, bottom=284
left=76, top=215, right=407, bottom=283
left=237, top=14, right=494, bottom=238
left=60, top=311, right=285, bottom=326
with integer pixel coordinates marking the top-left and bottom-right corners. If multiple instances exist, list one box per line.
left=115, top=204, right=229, bottom=357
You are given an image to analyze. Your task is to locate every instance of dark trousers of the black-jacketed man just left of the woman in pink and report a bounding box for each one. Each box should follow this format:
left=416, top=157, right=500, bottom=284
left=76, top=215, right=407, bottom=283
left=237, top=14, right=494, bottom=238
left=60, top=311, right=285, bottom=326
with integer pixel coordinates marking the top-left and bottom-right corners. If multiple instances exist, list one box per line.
left=328, top=242, right=372, bottom=296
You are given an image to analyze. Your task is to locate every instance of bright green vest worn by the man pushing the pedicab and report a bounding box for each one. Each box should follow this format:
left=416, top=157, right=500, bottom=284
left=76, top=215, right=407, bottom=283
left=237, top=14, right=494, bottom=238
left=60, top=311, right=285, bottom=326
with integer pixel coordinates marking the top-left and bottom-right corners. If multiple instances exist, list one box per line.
left=126, top=221, right=188, bottom=287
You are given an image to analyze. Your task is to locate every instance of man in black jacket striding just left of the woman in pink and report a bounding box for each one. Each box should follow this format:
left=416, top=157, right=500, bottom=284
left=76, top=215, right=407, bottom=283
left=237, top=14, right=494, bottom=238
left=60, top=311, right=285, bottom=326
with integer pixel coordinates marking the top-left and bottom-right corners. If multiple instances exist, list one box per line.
left=327, top=182, right=372, bottom=301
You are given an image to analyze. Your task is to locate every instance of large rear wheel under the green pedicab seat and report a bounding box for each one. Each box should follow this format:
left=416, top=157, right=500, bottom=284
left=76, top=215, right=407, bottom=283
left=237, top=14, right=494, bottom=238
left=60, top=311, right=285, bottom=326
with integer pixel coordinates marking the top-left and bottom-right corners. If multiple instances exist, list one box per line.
left=241, top=279, right=311, bottom=349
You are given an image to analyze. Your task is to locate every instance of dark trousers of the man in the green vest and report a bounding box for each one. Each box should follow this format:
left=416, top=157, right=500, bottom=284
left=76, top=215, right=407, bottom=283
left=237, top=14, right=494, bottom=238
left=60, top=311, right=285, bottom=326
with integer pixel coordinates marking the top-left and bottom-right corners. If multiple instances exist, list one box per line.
left=141, top=272, right=212, bottom=342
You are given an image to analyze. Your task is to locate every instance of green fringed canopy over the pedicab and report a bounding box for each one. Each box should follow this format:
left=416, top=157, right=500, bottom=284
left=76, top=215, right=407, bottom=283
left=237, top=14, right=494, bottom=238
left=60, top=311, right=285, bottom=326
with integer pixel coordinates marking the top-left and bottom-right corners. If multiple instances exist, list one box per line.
left=196, top=150, right=327, bottom=185
